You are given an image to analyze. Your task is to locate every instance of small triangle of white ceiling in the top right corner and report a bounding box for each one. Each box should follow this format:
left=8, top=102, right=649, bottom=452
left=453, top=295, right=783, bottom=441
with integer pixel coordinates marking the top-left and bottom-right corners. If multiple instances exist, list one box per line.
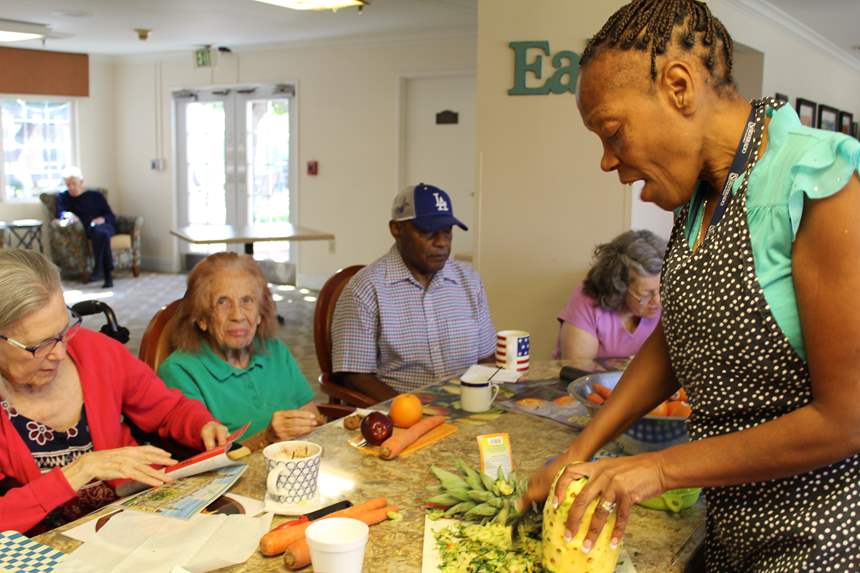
left=769, top=0, right=860, bottom=61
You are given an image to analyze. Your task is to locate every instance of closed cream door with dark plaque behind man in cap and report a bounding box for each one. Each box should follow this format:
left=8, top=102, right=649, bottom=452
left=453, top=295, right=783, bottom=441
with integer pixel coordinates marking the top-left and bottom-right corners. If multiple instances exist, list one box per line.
left=402, top=74, right=477, bottom=260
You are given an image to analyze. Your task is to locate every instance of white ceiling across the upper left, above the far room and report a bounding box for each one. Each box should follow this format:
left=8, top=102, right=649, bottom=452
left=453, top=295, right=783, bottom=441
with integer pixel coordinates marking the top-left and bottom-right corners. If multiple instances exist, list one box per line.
left=0, top=0, right=478, bottom=55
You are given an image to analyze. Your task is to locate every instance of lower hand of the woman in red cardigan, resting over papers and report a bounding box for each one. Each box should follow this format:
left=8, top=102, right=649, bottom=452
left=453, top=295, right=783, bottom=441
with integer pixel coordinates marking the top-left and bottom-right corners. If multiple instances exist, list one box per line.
left=62, top=446, right=176, bottom=491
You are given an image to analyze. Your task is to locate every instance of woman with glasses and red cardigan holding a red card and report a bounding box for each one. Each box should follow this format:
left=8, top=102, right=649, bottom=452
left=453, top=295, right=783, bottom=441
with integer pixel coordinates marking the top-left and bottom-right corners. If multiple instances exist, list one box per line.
left=0, top=249, right=227, bottom=534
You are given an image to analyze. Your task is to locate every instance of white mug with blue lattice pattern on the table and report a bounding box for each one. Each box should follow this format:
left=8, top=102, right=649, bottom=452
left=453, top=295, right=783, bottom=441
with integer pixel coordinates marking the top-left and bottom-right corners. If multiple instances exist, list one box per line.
left=263, top=440, right=322, bottom=504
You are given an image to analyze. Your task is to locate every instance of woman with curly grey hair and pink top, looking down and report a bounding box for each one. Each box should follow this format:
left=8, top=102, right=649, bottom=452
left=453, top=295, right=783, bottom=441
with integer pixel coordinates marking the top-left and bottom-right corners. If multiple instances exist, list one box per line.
left=555, top=230, right=666, bottom=363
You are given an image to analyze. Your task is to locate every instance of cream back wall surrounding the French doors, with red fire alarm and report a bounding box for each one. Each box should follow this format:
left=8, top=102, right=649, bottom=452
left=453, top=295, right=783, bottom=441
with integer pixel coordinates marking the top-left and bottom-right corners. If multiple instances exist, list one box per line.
left=111, top=36, right=475, bottom=280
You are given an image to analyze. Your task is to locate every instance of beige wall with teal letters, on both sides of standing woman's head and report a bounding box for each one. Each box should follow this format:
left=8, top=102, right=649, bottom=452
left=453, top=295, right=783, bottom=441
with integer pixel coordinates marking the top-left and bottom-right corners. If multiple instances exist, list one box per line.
left=476, top=0, right=860, bottom=358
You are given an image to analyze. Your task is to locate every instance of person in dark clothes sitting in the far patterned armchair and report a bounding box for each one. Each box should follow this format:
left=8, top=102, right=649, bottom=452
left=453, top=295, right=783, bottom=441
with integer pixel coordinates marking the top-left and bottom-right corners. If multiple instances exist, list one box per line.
left=56, top=167, right=116, bottom=288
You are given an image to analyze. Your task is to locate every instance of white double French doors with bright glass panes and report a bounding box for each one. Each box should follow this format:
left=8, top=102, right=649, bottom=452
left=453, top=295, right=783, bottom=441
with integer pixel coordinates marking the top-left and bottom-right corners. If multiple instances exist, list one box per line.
left=174, top=85, right=295, bottom=262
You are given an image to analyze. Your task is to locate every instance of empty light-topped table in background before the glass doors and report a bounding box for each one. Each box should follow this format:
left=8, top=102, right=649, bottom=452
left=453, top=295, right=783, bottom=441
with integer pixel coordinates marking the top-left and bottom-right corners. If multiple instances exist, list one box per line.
left=170, top=223, right=334, bottom=255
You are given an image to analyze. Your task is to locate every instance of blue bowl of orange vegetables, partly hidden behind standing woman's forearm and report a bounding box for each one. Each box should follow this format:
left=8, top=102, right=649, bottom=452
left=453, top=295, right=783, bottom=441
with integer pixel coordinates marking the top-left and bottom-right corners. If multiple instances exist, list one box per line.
left=567, top=372, right=691, bottom=451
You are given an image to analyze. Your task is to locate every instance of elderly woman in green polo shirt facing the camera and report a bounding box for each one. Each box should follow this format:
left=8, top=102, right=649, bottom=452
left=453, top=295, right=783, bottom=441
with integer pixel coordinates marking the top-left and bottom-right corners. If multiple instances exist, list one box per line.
left=158, top=253, right=320, bottom=449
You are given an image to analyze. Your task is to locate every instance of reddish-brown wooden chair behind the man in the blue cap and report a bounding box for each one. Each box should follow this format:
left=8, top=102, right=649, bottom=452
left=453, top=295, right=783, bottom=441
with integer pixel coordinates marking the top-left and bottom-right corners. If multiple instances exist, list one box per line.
left=314, top=265, right=378, bottom=408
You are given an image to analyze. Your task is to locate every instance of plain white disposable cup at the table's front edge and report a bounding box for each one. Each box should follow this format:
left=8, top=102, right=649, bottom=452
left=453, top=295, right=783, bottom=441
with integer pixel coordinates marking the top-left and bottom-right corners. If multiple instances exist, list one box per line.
left=305, top=517, right=369, bottom=573
